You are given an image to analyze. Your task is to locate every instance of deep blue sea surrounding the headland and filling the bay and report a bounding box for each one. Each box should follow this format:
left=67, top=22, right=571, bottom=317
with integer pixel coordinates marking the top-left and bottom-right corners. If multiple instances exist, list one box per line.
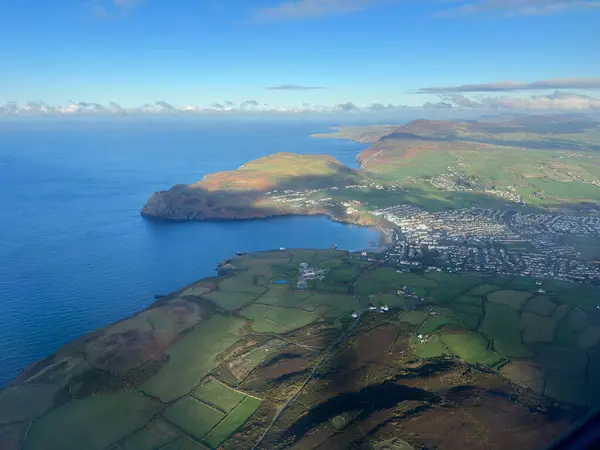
left=0, top=119, right=379, bottom=385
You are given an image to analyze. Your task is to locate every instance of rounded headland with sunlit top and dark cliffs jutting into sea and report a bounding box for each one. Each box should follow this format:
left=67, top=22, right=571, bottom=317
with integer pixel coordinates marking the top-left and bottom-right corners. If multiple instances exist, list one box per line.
left=141, top=153, right=367, bottom=223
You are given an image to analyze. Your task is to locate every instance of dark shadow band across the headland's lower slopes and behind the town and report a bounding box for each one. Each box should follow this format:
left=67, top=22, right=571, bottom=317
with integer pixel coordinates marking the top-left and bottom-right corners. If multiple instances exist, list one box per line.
left=142, top=165, right=597, bottom=222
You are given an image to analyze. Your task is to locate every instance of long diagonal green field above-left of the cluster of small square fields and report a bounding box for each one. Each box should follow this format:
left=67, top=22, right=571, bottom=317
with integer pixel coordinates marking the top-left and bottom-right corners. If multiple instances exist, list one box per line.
left=141, top=315, right=246, bottom=402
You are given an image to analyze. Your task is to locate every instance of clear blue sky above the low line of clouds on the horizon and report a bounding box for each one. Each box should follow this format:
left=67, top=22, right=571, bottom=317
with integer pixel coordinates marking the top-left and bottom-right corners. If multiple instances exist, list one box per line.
left=0, top=0, right=600, bottom=112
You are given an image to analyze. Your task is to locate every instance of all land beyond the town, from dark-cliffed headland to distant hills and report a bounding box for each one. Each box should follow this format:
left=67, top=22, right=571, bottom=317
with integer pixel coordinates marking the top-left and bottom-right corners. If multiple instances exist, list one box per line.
left=142, top=116, right=600, bottom=224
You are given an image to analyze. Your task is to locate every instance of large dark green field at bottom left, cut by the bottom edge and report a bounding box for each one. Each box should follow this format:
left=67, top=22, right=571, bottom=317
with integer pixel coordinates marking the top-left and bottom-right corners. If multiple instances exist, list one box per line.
left=23, top=392, right=162, bottom=450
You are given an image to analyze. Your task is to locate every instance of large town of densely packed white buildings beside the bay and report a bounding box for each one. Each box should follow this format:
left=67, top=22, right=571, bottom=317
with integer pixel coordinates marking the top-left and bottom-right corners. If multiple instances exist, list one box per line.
left=373, top=204, right=600, bottom=284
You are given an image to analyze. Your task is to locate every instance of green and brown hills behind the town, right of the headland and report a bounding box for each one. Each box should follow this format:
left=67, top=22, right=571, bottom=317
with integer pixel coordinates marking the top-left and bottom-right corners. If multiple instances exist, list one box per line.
left=352, top=116, right=600, bottom=207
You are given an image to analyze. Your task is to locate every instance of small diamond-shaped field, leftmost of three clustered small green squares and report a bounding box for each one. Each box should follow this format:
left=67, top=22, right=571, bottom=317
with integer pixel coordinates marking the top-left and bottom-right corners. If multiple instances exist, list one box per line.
left=162, top=396, right=225, bottom=440
